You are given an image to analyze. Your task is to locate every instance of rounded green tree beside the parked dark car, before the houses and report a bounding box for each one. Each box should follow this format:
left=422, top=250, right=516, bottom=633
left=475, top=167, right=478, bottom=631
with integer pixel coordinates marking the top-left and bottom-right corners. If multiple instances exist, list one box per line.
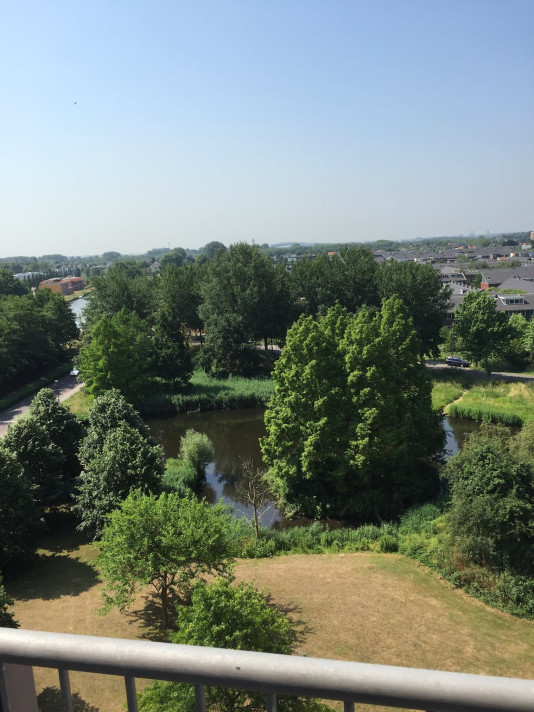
left=452, top=292, right=510, bottom=373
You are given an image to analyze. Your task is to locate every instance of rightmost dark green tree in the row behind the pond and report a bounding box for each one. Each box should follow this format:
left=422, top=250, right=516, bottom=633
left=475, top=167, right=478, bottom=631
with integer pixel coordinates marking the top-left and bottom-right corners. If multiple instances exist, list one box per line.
left=377, top=260, right=451, bottom=356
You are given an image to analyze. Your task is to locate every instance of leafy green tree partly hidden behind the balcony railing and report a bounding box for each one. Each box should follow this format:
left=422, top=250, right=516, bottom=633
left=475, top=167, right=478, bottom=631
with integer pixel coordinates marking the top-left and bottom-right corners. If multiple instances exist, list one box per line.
left=139, top=579, right=327, bottom=712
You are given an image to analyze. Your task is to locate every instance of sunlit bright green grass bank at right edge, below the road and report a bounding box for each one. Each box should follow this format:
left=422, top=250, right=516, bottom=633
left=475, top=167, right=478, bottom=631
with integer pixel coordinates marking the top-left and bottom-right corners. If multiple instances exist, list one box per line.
left=447, top=381, right=534, bottom=426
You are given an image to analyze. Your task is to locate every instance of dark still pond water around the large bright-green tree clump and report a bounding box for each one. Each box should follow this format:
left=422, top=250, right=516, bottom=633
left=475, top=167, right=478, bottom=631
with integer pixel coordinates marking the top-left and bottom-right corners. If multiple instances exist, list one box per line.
left=148, top=408, right=479, bottom=528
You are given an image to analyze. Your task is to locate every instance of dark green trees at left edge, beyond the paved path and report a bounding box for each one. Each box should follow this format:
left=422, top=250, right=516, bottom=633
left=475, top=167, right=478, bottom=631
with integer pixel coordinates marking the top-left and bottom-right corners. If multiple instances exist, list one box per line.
left=0, top=286, right=78, bottom=392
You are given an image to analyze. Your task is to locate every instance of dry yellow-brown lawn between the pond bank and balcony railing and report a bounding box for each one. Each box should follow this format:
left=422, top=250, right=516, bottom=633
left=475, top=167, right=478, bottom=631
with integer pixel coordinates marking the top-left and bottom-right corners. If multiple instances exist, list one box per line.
left=8, top=532, right=534, bottom=712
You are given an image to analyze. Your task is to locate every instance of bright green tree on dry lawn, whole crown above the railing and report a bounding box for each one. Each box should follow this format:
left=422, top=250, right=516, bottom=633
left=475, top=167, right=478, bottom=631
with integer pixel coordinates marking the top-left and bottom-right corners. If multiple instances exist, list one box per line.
left=98, top=491, right=239, bottom=628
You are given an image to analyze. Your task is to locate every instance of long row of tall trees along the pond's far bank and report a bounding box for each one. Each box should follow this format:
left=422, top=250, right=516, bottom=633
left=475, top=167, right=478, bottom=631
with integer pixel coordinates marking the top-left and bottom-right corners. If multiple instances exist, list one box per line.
left=79, top=243, right=449, bottom=394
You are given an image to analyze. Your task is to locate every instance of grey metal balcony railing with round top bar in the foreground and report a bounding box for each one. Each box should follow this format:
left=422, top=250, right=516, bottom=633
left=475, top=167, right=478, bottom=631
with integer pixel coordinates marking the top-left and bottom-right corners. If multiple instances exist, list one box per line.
left=0, top=628, right=534, bottom=712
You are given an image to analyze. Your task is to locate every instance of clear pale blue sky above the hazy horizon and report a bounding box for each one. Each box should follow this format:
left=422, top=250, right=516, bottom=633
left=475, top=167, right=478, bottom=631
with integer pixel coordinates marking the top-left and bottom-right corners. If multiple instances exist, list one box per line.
left=0, top=0, right=534, bottom=256
